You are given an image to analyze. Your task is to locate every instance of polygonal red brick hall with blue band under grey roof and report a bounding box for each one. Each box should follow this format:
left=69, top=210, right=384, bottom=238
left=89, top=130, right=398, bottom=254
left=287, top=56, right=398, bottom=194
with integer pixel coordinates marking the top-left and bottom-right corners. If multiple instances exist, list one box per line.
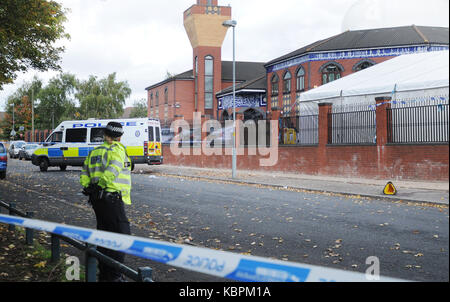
left=265, top=25, right=449, bottom=117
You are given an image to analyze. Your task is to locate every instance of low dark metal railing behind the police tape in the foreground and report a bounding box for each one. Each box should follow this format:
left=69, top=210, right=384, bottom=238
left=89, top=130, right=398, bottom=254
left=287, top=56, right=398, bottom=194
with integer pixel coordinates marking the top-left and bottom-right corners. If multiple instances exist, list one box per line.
left=0, top=201, right=153, bottom=282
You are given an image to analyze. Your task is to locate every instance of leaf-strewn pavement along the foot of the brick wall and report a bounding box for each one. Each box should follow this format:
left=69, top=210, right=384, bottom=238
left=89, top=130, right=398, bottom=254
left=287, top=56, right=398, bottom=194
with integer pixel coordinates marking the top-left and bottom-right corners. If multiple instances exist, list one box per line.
left=139, top=164, right=449, bottom=206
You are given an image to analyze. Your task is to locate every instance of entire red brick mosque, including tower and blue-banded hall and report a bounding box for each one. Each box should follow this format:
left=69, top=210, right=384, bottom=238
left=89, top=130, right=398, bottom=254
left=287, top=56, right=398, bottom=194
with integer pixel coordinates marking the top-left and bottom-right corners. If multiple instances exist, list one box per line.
left=146, top=0, right=449, bottom=125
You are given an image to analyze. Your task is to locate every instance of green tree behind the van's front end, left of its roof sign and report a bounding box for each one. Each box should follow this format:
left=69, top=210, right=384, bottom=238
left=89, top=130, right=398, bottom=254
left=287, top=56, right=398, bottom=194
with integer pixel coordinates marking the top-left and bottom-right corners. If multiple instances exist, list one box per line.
left=36, top=73, right=77, bottom=129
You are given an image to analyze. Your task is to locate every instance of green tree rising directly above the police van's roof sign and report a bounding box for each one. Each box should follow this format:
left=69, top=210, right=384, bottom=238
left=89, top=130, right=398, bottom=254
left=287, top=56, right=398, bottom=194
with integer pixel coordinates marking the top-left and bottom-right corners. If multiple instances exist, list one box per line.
left=76, top=73, right=131, bottom=119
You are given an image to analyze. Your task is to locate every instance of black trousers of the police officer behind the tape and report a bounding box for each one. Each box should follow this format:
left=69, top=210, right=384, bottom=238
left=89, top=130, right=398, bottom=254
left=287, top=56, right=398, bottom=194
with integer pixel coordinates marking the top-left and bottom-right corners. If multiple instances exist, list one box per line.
left=91, top=198, right=131, bottom=282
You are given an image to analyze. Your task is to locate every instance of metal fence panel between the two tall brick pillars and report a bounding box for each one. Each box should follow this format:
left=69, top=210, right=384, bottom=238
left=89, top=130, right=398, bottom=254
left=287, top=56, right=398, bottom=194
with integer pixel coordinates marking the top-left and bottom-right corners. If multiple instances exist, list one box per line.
left=328, top=110, right=377, bottom=145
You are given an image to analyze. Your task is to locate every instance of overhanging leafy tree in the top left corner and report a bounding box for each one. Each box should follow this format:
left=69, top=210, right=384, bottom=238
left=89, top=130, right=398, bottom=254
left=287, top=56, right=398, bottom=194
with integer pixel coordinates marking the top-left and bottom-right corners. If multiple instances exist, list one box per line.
left=0, top=0, right=70, bottom=89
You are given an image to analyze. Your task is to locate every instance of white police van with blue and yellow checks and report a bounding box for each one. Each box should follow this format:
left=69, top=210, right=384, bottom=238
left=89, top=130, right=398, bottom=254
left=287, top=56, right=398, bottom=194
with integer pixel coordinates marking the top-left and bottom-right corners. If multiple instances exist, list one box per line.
left=31, top=118, right=163, bottom=172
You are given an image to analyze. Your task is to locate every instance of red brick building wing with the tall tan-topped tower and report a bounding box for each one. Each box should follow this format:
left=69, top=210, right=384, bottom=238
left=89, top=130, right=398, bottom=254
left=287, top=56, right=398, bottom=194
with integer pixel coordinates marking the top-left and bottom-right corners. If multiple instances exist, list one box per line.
left=146, top=0, right=265, bottom=125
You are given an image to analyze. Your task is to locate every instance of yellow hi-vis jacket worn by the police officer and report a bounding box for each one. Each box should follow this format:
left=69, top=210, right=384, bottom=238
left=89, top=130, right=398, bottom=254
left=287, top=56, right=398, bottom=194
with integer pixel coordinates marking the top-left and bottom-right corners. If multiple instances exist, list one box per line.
left=80, top=142, right=131, bottom=205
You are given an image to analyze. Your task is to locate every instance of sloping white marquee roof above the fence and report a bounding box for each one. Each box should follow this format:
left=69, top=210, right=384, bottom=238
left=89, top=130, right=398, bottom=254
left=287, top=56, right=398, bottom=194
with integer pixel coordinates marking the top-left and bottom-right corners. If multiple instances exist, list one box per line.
left=300, top=50, right=449, bottom=112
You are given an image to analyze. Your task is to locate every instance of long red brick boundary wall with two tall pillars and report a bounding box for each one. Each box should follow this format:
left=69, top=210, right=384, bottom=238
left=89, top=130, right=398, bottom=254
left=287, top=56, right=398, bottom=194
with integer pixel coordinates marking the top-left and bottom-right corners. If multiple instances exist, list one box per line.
left=163, top=98, right=449, bottom=181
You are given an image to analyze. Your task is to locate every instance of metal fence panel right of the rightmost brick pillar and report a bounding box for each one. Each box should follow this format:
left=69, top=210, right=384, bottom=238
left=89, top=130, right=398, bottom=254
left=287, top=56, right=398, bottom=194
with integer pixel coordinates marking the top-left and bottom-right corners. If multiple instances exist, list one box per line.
left=387, top=104, right=449, bottom=143
